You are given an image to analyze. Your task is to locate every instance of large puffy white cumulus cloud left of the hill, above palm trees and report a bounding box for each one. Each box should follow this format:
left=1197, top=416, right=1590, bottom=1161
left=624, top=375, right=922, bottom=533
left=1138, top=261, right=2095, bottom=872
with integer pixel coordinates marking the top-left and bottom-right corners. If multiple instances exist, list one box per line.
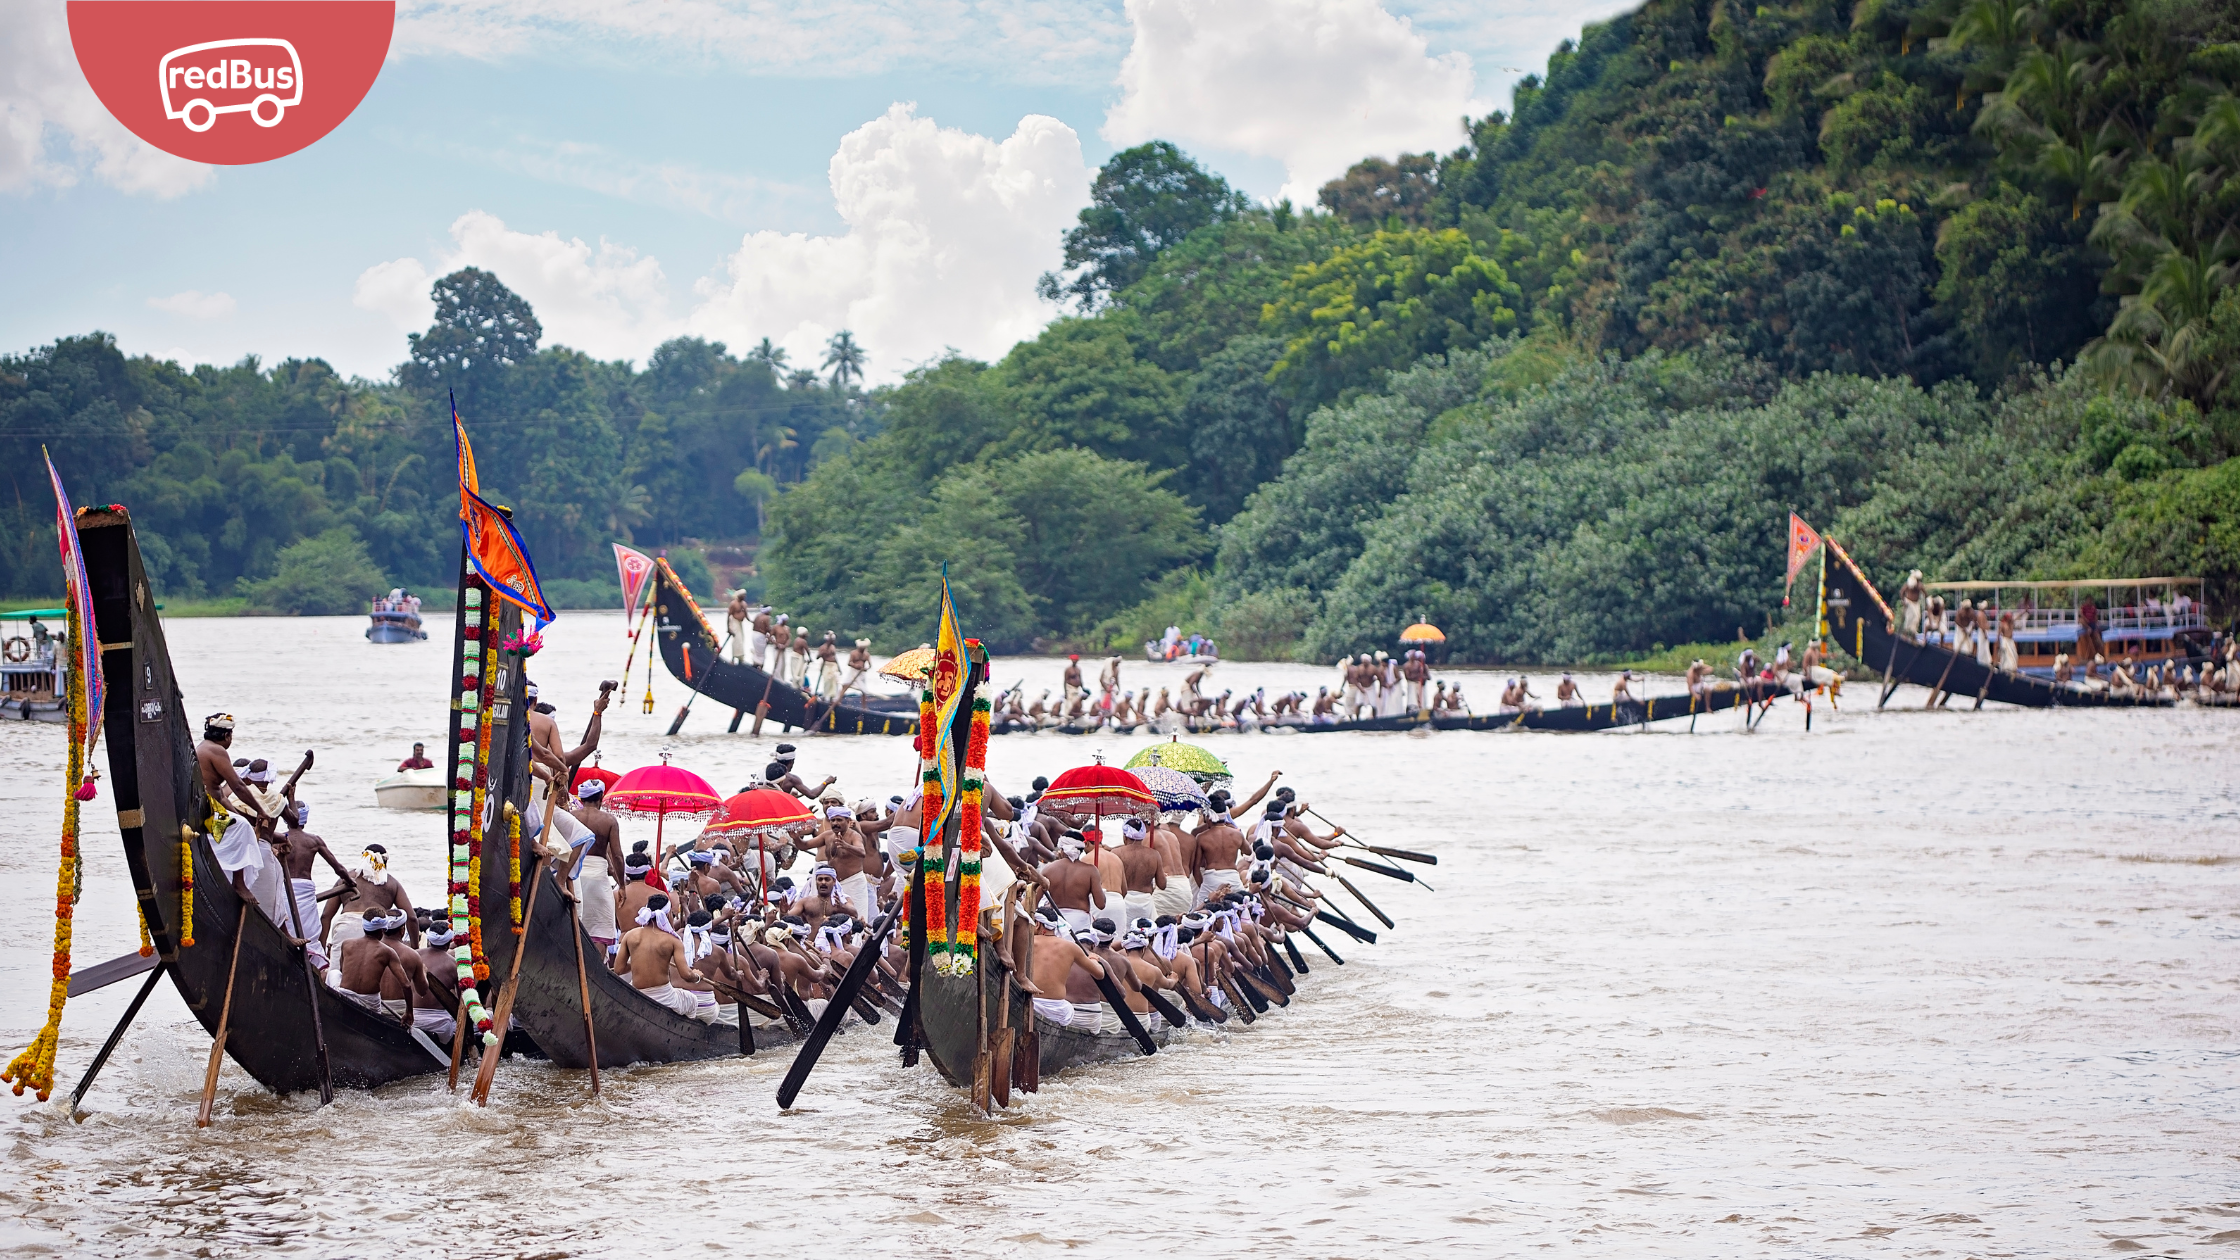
left=690, top=103, right=1091, bottom=379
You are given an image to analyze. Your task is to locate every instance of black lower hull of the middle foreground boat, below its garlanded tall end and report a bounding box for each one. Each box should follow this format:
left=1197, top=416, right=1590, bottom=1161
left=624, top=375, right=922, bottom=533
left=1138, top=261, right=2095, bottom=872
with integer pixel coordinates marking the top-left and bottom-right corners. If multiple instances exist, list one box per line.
left=484, top=845, right=800, bottom=1067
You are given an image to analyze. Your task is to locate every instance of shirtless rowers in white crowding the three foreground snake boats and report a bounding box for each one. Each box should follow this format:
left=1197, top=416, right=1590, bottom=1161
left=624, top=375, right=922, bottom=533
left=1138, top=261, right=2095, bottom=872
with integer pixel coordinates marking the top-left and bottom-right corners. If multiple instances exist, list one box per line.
left=197, top=693, right=1344, bottom=1043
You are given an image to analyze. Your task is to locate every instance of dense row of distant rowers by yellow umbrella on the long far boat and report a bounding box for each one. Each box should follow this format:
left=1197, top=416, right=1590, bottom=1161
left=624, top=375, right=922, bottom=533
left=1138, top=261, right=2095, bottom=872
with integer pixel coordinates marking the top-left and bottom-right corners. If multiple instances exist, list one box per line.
left=995, top=650, right=1467, bottom=735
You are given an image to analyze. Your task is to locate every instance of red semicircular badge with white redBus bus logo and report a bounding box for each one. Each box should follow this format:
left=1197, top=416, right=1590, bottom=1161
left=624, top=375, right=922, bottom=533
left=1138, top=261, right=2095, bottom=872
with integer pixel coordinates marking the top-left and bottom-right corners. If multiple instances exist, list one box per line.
left=69, top=0, right=396, bottom=166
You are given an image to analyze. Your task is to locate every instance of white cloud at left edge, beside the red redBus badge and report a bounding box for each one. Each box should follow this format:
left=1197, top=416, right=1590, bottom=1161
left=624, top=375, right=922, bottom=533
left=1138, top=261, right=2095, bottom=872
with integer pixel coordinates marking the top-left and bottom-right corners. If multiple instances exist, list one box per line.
left=0, top=2, right=215, bottom=197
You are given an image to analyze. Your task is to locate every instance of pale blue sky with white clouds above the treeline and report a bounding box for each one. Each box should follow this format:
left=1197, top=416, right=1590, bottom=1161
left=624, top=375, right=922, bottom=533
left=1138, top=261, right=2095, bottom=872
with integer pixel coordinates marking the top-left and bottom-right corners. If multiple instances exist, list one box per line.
left=0, top=0, right=1631, bottom=383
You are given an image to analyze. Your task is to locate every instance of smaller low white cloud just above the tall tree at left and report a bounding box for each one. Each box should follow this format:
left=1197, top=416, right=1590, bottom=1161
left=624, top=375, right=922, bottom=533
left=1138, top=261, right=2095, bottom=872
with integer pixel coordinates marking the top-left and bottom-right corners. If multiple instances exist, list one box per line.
left=352, top=211, right=679, bottom=359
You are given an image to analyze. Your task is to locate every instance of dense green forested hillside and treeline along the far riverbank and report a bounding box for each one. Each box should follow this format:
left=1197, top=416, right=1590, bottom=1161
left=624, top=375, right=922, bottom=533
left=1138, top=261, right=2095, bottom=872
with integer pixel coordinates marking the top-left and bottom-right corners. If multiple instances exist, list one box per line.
left=0, top=0, right=2240, bottom=659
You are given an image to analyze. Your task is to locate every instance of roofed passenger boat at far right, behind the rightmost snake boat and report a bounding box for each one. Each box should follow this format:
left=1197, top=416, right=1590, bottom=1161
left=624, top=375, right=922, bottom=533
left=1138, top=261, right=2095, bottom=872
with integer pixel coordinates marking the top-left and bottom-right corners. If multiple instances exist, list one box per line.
left=1922, top=578, right=2213, bottom=679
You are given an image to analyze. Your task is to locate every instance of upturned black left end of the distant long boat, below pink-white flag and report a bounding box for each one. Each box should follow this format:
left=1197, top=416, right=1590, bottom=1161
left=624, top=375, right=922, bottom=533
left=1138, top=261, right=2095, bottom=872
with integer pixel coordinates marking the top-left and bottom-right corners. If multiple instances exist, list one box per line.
left=647, top=558, right=918, bottom=735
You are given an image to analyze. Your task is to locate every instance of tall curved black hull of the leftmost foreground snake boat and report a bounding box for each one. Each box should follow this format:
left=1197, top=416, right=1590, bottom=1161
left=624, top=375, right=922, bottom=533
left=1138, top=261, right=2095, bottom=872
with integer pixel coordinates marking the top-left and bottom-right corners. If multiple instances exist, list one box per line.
left=78, top=511, right=446, bottom=1094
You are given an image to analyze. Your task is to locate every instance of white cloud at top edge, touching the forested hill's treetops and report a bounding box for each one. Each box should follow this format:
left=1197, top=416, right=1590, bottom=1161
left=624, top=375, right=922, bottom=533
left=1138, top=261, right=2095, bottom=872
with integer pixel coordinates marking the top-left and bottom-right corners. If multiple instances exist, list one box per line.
left=1102, top=0, right=1487, bottom=204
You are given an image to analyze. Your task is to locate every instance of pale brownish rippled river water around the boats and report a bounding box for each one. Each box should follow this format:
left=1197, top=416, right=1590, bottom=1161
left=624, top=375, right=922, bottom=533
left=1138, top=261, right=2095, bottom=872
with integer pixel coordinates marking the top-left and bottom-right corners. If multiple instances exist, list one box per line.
left=0, top=614, right=2240, bottom=1258
